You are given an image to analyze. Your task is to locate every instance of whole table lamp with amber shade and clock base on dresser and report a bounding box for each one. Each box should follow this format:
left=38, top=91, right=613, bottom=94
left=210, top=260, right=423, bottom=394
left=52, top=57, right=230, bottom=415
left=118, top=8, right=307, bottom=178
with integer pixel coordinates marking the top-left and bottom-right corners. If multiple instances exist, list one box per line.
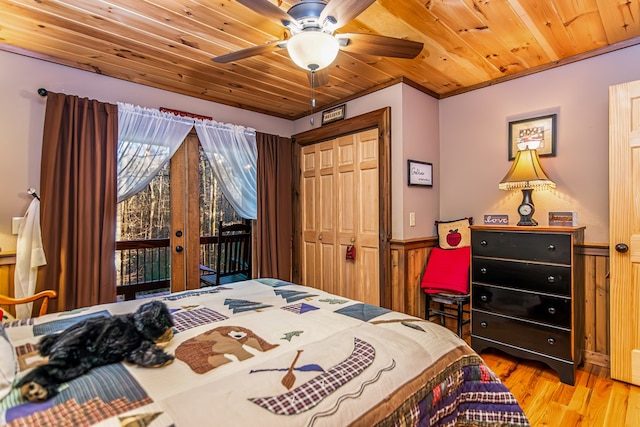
left=498, top=148, right=556, bottom=226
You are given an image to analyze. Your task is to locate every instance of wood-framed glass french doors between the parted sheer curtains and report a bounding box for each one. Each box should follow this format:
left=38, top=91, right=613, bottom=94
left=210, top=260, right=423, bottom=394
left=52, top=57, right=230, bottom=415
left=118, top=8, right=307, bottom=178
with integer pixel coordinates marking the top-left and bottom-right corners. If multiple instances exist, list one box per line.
left=115, top=132, right=241, bottom=299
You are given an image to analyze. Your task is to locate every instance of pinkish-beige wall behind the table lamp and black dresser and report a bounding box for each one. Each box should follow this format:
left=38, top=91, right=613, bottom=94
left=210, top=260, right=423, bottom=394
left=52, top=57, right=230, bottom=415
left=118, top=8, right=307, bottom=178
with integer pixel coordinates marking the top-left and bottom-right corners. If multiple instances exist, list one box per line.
left=440, top=46, right=640, bottom=243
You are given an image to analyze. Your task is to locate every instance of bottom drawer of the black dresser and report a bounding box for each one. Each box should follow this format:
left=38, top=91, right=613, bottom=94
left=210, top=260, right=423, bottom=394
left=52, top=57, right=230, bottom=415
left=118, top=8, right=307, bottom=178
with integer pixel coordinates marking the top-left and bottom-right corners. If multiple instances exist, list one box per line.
left=471, top=309, right=572, bottom=360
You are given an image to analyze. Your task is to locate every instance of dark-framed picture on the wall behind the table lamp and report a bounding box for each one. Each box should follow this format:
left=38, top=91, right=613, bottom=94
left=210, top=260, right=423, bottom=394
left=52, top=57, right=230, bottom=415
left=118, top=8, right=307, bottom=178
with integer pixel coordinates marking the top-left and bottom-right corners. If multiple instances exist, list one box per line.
left=509, top=114, right=557, bottom=160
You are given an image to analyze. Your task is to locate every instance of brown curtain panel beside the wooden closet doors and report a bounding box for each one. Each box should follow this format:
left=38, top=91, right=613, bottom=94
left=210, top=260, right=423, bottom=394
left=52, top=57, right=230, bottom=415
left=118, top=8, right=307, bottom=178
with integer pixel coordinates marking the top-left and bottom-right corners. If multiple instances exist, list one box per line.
left=253, top=132, right=293, bottom=281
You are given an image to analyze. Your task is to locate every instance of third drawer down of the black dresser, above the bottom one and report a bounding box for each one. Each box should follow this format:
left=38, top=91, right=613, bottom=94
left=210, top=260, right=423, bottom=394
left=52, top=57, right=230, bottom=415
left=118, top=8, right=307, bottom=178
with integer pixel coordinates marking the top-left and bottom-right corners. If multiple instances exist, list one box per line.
left=471, top=283, right=571, bottom=329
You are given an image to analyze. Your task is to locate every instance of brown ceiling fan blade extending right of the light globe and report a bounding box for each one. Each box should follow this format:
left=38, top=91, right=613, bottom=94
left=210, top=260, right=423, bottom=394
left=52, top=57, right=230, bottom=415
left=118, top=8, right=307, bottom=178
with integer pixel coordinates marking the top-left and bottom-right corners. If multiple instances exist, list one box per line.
left=336, top=33, right=424, bottom=59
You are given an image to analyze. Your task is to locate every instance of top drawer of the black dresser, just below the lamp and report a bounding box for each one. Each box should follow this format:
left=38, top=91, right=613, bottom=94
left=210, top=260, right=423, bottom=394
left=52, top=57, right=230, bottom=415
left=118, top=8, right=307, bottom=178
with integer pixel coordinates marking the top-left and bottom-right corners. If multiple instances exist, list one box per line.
left=471, top=230, right=572, bottom=265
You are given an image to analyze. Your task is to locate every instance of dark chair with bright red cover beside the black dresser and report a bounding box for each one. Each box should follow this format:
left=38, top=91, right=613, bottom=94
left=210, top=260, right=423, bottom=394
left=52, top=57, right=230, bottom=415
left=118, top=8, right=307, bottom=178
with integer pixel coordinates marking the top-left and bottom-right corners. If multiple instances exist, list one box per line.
left=420, top=246, right=471, bottom=337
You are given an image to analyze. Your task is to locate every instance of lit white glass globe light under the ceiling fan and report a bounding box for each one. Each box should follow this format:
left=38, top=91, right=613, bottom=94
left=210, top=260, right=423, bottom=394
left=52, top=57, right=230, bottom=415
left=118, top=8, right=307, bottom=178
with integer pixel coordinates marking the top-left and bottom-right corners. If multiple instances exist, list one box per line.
left=287, top=31, right=340, bottom=71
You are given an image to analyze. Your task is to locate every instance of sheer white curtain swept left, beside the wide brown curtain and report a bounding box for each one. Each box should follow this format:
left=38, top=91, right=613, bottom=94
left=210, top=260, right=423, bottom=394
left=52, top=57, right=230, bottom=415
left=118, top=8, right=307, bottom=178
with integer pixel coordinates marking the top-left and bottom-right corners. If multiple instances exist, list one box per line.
left=118, top=102, right=194, bottom=203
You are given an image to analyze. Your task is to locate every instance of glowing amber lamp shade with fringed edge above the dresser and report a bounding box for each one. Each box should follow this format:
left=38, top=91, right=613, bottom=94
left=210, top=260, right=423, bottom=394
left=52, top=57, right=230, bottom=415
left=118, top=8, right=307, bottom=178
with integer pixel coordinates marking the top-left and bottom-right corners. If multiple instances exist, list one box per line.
left=498, top=149, right=556, bottom=190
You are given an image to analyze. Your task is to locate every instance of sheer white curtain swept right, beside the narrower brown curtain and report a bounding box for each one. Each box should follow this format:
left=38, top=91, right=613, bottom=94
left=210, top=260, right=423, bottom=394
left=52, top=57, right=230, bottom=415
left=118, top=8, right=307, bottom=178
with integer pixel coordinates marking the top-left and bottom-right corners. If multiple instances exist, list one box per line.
left=195, top=120, right=258, bottom=219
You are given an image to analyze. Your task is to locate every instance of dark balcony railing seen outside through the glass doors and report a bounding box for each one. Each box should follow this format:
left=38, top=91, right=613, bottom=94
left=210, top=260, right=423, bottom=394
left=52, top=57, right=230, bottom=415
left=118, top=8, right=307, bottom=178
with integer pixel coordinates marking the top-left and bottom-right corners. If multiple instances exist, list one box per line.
left=116, top=234, right=251, bottom=300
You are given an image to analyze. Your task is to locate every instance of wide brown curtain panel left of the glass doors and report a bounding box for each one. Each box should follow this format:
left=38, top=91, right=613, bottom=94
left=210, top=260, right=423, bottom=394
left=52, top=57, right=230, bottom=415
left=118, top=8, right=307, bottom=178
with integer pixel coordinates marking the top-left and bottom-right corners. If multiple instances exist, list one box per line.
left=37, top=92, right=118, bottom=311
